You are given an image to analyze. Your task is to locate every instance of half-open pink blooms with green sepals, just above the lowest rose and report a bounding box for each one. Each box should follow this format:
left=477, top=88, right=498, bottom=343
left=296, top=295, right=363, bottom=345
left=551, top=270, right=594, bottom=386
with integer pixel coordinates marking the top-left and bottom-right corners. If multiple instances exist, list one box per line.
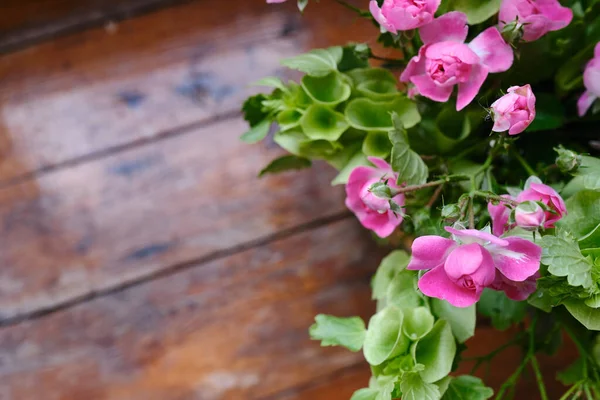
left=488, top=178, right=567, bottom=236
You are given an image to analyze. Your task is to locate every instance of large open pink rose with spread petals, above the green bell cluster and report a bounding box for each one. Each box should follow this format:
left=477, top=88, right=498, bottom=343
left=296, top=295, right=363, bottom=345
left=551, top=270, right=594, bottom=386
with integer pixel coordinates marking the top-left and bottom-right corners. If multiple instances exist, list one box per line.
left=400, top=12, right=513, bottom=110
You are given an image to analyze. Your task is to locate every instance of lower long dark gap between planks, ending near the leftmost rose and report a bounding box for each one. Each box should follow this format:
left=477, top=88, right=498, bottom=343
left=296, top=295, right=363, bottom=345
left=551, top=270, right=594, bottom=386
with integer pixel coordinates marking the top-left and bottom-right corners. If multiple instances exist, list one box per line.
left=0, top=211, right=352, bottom=328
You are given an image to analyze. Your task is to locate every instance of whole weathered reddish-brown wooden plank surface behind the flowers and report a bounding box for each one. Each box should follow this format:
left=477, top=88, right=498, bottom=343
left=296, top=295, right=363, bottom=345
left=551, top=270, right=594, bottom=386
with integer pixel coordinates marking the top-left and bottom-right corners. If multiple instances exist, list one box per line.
left=0, top=0, right=572, bottom=400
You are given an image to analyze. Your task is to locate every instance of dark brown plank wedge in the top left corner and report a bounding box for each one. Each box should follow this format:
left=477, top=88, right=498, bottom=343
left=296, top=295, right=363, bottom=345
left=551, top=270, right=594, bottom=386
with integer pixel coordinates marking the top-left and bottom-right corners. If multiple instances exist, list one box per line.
left=0, top=0, right=186, bottom=52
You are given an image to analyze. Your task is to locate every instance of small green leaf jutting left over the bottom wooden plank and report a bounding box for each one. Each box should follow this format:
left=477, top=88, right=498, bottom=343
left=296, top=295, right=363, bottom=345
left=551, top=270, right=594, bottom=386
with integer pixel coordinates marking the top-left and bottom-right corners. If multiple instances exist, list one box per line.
left=309, top=314, right=366, bottom=352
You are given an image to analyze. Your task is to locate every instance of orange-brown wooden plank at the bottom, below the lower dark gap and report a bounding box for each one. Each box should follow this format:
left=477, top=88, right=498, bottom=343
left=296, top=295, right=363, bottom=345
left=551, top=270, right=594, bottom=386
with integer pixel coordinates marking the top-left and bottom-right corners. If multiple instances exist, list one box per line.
left=0, top=220, right=381, bottom=400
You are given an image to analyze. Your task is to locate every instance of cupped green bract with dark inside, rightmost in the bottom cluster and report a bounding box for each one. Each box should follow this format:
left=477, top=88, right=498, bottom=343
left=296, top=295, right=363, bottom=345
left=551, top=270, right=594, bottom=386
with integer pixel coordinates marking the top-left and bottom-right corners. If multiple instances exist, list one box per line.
left=415, top=320, right=456, bottom=383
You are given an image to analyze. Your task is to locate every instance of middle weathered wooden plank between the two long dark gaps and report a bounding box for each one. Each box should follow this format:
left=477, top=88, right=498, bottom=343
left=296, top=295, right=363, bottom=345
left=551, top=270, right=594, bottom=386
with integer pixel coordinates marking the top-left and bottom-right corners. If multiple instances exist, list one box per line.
left=0, top=119, right=352, bottom=319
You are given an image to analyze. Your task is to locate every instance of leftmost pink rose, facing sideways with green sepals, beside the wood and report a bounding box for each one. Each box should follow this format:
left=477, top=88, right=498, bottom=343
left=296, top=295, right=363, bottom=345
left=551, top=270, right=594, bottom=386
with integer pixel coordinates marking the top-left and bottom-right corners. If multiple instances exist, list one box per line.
left=346, top=157, right=404, bottom=238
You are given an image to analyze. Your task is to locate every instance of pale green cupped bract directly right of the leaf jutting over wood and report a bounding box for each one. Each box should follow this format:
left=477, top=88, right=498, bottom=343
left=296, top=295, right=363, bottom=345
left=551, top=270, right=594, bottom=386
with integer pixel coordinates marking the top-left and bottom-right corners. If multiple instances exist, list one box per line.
left=363, top=307, right=409, bottom=365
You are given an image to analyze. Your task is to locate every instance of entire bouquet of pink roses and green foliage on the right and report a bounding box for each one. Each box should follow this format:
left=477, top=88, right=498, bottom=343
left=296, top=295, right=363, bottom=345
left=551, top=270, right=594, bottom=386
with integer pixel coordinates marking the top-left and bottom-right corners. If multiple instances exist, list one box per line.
left=242, top=0, right=600, bottom=400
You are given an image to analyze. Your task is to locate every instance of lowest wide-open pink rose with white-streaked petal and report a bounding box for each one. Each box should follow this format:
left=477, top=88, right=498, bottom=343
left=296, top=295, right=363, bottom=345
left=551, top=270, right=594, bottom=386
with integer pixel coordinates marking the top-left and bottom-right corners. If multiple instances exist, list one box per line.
left=407, top=227, right=542, bottom=307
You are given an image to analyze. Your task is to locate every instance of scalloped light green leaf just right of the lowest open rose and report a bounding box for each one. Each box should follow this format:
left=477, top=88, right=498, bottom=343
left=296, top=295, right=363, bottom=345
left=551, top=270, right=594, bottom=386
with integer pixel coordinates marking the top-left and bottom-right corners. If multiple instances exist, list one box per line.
left=539, top=235, right=593, bottom=289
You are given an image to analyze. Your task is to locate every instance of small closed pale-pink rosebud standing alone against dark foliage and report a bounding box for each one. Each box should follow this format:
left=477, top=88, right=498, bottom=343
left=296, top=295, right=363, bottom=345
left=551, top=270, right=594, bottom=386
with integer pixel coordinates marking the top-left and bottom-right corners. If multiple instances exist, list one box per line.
left=491, top=85, right=535, bottom=135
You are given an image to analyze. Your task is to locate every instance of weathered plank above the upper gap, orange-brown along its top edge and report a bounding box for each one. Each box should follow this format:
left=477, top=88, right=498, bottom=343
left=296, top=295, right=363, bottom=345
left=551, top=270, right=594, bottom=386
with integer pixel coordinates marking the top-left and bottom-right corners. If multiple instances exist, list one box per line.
left=0, top=0, right=375, bottom=183
